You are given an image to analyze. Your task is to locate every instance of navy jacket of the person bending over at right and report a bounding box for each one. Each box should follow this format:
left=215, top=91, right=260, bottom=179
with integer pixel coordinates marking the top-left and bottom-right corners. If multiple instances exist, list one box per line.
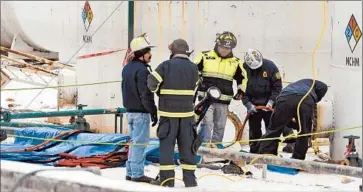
left=279, top=79, right=328, bottom=103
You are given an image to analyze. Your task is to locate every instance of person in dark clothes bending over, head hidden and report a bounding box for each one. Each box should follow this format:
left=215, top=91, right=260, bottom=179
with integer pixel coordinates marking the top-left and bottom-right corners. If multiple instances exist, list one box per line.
left=258, top=79, right=328, bottom=160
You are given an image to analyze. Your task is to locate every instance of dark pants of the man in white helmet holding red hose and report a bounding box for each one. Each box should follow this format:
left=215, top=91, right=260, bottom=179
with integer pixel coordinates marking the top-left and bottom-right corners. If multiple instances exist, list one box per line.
left=248, top=110, right=293, bottom=153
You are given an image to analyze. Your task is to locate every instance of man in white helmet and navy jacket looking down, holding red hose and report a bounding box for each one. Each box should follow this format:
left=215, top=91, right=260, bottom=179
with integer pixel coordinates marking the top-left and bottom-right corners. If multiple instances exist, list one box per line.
left=242, top=49, right=293, bottom=153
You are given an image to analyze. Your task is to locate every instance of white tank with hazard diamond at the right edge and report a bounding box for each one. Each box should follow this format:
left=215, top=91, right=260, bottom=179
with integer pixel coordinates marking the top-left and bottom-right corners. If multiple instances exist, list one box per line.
left=329, top=1, right=363, bottom=159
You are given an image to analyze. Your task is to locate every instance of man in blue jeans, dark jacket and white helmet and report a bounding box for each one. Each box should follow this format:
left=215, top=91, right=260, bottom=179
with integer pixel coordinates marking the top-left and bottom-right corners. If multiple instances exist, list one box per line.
left=122, top=34, right=158, bottom=183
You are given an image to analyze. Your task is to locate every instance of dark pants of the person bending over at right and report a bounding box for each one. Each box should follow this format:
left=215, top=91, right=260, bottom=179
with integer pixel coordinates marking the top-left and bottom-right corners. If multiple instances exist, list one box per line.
left=258, top=95, right=314, bottom=160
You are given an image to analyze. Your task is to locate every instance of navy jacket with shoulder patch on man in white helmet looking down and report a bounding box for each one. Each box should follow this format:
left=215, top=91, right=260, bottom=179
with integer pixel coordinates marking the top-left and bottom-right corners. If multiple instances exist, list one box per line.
left=242, top=59, right=282, bottom=106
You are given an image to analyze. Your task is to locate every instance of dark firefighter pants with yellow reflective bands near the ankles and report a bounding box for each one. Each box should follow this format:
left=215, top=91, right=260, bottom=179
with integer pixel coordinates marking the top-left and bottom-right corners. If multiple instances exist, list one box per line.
left=157, top=117, right=197, bottom=187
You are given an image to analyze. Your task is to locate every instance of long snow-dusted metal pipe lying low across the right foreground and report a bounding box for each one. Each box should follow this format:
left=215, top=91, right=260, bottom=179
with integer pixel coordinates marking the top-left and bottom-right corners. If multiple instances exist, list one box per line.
left=198, top=147, right=363, bottom=178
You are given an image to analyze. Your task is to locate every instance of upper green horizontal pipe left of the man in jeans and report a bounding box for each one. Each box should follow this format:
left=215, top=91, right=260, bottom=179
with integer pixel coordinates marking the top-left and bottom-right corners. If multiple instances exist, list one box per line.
left=2, top=108, right=126, bottom=122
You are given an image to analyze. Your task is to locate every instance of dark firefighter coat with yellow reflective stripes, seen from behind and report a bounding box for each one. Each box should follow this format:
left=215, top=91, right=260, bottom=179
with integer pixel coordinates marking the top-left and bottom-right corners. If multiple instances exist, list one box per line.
left=148, top=54, right=199, bottom=117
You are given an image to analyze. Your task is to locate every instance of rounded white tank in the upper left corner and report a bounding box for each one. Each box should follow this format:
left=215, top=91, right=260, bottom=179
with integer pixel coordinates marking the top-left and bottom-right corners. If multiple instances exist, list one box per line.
left=1, top=1, right=91, bottom=63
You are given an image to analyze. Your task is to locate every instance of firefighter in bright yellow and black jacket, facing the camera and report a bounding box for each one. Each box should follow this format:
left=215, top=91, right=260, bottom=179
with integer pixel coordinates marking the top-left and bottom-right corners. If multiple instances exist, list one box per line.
left=195, top=31, right=247, bottom=145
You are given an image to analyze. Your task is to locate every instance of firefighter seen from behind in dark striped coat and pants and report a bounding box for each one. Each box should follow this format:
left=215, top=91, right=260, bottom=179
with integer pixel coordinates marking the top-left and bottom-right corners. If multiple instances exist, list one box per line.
left=148, top=39, right=199, bottom=187
